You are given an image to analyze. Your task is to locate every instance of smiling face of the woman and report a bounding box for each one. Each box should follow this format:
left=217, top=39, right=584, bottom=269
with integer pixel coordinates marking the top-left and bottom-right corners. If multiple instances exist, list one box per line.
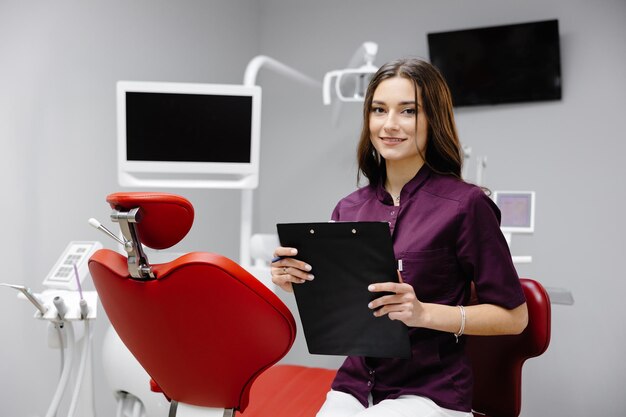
left=369, top=77, right=428, bottom=170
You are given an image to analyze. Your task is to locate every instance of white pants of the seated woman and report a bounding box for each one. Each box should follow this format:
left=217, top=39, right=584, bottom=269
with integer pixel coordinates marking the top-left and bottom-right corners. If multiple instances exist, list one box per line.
left=316, top=390, right=472, bottom=417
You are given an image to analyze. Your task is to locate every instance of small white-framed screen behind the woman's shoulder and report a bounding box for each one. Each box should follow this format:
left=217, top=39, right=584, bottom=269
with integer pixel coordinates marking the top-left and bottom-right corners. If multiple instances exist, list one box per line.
left=493, top=191, right=535, bottom=233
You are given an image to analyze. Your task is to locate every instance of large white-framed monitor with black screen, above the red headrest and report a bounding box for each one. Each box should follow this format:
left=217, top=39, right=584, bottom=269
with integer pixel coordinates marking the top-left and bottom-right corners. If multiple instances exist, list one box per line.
left=117, top=81, right=261, bottom=188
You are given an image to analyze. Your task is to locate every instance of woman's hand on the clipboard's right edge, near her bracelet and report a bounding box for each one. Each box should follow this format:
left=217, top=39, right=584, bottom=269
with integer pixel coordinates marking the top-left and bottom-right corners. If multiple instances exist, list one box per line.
left=367, top=272, right=425, bottom=327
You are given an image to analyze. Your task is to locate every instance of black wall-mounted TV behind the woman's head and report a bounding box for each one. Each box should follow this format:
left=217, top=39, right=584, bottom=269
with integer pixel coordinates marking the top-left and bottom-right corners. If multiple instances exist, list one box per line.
left=428, top=20, right=561, bottom=107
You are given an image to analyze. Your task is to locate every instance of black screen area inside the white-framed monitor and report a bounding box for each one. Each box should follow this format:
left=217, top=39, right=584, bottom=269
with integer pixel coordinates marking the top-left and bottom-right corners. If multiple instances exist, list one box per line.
left=126, top=92, right=252, bottom=163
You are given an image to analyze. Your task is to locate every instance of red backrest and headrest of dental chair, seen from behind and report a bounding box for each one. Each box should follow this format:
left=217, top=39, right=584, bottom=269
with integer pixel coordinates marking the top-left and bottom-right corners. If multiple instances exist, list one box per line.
left=89, top=193, right=296, bottom=417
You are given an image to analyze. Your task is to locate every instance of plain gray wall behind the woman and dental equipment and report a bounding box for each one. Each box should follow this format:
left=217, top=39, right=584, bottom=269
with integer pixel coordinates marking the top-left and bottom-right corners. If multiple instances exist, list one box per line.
left=0, top=0, right=626, bottom=416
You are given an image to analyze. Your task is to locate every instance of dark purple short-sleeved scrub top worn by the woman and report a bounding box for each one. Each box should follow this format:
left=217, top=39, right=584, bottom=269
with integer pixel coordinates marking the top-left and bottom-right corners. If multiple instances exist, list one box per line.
left=332, top=166, right=526, bottom=411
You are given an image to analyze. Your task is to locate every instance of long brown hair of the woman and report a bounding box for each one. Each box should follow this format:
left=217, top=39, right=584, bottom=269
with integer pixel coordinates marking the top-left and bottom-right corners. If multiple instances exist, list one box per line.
left=357, top=58, right=463, bottom=185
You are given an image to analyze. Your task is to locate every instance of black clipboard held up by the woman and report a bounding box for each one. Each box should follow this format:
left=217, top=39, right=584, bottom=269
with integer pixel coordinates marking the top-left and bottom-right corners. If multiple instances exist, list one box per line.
left=276, top=222, right=411, bottom=358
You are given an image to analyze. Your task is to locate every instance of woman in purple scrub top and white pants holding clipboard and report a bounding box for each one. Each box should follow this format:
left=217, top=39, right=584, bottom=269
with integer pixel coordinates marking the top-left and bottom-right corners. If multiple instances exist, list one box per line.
left=272, top=59, right=528, bottom=417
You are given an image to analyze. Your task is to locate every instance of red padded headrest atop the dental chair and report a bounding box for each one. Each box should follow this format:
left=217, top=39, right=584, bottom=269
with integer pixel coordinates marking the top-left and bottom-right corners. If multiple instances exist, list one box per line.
left=106, top=192, right=194, bottom=249
